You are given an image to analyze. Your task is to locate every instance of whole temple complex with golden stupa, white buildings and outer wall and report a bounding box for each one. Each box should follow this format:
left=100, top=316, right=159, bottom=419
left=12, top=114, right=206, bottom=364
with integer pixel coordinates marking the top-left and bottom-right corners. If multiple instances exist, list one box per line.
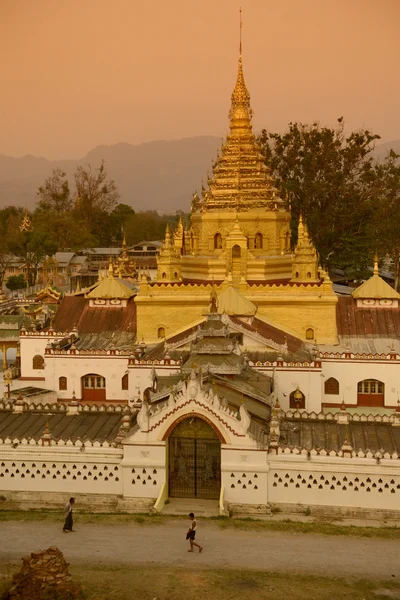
left=0, top=44, right=400, bottom=516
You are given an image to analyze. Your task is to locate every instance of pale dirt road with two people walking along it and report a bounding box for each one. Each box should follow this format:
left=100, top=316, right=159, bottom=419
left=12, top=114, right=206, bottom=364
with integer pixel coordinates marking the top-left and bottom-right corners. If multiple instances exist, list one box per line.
left=0, top=520, right=400, bottom=581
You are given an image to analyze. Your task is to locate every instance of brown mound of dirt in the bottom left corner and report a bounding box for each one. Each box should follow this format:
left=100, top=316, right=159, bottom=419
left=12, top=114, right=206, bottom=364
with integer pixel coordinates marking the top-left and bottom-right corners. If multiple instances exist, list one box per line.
left=2, top=546, right=83, bottom=600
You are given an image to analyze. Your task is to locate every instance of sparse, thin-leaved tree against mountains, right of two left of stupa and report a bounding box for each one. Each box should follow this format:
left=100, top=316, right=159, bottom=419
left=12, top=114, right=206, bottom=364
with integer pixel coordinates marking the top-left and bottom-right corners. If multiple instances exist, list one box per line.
left=74, top=161, right=119, bottom=233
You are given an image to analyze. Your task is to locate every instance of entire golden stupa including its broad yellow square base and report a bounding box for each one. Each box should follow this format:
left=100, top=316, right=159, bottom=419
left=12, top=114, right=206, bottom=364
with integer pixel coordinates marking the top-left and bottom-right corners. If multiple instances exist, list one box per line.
left=135, top=28, right=337, bottom=343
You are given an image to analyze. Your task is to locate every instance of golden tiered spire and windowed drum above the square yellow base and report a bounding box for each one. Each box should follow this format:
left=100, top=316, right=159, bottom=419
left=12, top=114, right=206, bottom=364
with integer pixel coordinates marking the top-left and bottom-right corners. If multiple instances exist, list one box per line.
left=178, top=46, right=292, bottom=283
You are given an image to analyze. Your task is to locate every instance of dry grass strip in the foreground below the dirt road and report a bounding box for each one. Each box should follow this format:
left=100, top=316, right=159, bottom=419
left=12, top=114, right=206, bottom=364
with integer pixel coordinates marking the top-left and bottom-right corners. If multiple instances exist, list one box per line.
left=0, top=564, right=400, bottom=600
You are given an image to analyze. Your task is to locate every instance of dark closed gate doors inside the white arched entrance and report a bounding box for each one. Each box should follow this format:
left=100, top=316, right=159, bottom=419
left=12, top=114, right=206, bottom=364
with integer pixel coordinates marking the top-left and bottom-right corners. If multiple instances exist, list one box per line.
left=168, top=417, right=221, bottom=499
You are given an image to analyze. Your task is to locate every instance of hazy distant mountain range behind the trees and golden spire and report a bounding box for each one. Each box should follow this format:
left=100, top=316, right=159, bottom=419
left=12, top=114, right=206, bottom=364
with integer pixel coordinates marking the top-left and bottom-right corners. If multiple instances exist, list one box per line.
left=0, top=136, right=400, bottom=213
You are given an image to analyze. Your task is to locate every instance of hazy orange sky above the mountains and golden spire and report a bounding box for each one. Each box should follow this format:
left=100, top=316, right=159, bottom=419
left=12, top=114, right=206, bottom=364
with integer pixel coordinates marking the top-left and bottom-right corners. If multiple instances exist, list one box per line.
left=0, top=0, right=400, bottom=158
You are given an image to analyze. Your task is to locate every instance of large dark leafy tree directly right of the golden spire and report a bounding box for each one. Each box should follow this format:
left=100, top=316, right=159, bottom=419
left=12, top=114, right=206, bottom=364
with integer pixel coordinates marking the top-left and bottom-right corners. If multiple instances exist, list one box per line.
left=260, top=118, right=379, bottom=272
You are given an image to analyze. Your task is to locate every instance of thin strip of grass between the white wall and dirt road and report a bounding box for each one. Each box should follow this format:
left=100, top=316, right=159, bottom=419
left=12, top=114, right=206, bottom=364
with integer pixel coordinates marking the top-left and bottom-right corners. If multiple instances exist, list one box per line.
left=0, top=510, right=400, bottom=539
